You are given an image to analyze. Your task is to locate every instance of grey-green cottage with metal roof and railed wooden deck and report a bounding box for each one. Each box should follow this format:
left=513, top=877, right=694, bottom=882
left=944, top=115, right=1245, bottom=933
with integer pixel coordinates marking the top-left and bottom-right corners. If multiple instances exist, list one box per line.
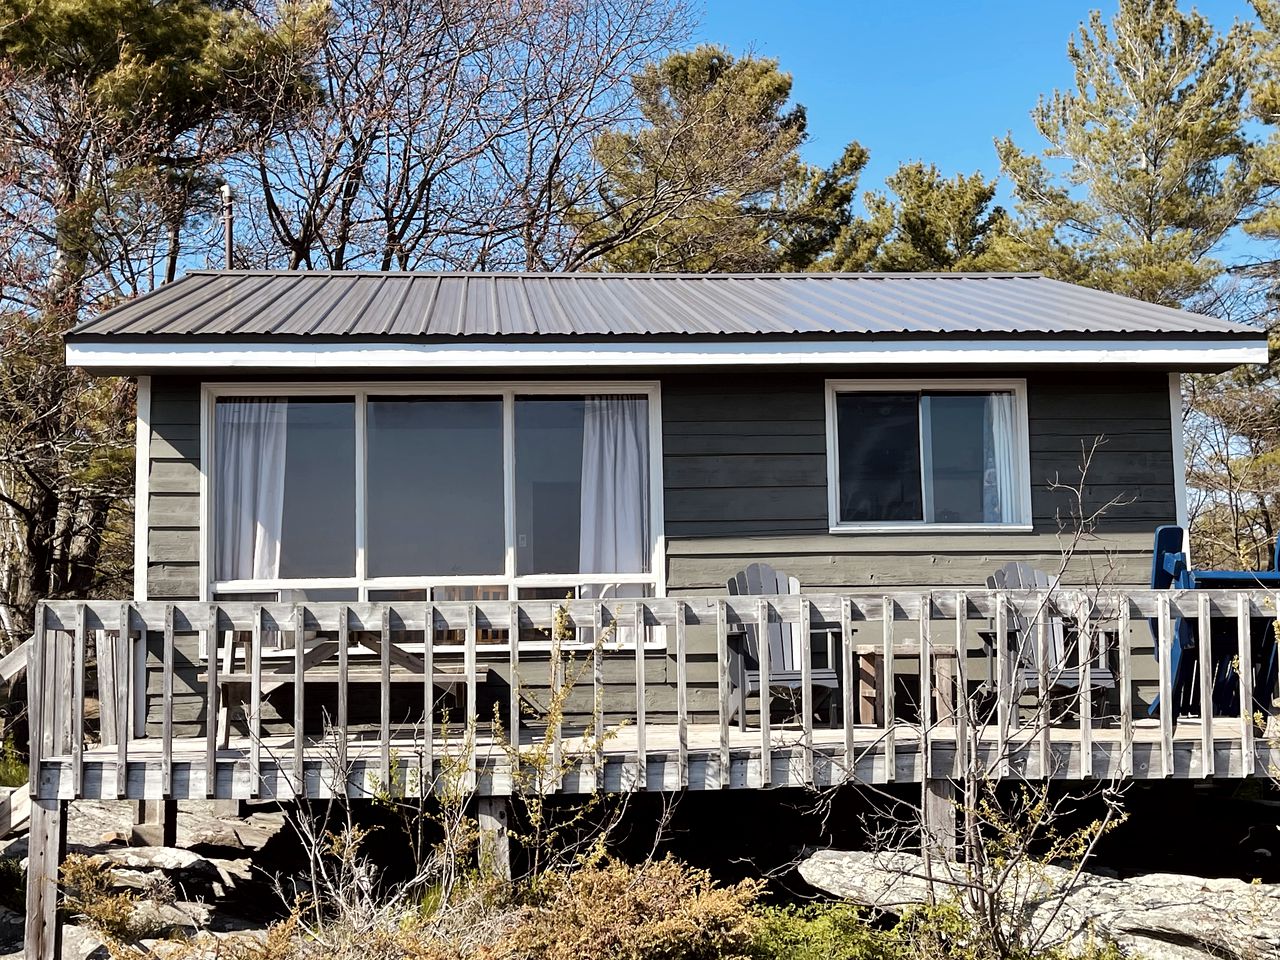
left=22, top=271, right=1270, bottom=960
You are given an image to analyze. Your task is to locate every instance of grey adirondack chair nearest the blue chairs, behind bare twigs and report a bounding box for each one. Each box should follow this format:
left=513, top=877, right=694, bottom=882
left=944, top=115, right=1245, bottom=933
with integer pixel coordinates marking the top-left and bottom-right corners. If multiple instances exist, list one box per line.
left=982, top=562, right=1116, bottom=698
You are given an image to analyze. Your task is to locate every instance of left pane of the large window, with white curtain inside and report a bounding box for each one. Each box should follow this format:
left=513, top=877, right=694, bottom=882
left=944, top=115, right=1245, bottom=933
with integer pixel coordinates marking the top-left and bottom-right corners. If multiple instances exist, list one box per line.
left=212, top=397, right=356, bottom=580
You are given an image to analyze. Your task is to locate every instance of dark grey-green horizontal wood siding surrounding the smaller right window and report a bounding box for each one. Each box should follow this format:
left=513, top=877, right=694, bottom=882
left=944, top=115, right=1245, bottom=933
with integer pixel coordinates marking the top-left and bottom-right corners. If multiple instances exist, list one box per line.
left=662, top=370, right=1176, bottom=716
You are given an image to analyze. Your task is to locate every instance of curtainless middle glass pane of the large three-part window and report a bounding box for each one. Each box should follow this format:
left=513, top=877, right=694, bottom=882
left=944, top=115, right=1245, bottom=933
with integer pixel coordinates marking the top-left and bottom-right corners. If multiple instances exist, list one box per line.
left=367, top=398, right=506, bottom=577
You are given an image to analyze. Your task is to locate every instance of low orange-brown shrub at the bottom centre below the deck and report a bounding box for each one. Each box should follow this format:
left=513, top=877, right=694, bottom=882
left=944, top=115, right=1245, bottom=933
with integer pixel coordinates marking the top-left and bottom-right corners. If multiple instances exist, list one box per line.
left=494, top=858, right=762, bottom=960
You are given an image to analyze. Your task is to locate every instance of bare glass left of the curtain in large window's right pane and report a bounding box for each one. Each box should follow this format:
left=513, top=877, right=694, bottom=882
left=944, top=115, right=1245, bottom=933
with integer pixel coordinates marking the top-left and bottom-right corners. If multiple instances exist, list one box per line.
left=516, top=397, right=584, bottom=575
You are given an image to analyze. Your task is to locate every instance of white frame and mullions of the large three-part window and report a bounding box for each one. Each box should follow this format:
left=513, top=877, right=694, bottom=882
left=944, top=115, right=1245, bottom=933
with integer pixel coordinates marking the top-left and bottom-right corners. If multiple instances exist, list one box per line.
left=200, top=380, right=667, bottom=650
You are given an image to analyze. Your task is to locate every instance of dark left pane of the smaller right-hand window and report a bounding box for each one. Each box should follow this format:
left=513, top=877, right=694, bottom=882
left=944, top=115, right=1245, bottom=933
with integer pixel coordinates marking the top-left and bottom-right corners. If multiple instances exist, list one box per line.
left=836, top=393, right=924, bottom=522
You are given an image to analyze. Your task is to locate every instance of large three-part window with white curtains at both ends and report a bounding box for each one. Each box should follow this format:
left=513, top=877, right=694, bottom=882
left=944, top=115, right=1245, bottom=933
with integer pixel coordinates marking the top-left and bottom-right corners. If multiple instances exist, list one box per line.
left=207, top=387, right=659, bottom=642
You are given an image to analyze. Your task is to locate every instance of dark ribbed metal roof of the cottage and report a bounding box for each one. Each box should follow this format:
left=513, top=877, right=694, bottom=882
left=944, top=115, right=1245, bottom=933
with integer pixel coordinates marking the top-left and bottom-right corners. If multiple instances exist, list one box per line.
left=68, top=271, right=1258, bottom=339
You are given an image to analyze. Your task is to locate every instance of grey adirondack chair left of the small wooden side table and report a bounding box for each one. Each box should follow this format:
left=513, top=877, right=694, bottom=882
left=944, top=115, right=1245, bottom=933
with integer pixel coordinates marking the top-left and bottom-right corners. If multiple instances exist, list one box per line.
left=728, top=563, right=840, bottom=730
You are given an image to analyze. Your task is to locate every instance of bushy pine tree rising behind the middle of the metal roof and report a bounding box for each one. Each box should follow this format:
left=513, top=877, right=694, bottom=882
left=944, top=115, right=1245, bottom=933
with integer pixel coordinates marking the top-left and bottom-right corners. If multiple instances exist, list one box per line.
left=577, top=46, right=867, bottom=271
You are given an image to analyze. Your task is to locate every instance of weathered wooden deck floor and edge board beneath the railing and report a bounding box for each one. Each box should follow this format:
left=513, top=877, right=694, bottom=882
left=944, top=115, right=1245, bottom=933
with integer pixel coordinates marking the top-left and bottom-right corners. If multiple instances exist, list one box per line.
left=38, top=718, right=1280, bottom=800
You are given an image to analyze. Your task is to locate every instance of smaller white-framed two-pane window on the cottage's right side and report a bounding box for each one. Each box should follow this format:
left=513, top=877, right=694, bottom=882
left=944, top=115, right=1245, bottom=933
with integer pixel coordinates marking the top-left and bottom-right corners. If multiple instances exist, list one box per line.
left=827, top=381, right=1030, bottom=529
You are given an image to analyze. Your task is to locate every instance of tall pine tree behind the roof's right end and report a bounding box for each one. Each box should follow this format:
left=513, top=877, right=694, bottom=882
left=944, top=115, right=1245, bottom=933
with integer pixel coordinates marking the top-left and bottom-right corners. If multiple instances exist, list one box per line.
left=997, top=0, right=1256, bottom=305
